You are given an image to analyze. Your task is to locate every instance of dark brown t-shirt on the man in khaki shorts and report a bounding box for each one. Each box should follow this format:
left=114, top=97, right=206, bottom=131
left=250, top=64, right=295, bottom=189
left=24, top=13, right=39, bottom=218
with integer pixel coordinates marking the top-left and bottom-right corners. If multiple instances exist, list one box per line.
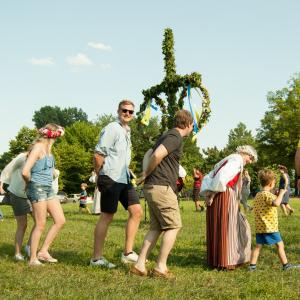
left=145, top=128, right=182, bottom=193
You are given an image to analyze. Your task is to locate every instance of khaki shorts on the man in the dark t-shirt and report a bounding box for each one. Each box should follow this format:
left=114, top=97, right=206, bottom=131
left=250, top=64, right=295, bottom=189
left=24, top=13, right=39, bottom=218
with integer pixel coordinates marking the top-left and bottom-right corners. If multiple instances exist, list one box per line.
left=144, top=185, right=182, bottom=231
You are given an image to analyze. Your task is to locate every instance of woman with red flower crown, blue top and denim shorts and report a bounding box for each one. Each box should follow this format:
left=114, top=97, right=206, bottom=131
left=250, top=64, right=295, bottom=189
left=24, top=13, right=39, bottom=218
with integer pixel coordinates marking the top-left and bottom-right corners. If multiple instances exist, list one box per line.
left=22, top=124, right=65, bottom=266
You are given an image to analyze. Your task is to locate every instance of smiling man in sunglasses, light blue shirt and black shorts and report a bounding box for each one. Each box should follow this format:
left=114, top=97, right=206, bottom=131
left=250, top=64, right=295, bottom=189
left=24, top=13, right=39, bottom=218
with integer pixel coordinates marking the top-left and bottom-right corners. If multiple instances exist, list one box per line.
left=90, top=100, right=142, bottom=268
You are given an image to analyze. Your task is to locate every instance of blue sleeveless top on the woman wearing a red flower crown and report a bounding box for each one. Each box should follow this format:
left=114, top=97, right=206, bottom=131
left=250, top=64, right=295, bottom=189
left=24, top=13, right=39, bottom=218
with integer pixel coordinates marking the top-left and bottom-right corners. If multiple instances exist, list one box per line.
left=30, top=155, right=54, bottom=186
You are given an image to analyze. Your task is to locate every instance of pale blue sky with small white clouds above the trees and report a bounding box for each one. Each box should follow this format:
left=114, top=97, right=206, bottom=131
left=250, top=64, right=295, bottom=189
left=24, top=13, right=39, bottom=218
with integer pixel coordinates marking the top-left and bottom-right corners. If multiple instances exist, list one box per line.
left=0, top=0, right=300, bottom=154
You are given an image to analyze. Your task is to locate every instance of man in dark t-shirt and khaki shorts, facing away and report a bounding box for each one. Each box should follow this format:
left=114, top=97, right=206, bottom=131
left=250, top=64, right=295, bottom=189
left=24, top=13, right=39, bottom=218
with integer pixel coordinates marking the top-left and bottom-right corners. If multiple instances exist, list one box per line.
left=131, top=110, right=193, bottom=279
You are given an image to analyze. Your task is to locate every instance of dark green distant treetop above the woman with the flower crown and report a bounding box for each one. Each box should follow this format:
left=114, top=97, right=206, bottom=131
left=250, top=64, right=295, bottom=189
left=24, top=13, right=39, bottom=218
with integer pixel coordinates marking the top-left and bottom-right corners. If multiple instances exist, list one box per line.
left=32, top=105, right=88, bottom=128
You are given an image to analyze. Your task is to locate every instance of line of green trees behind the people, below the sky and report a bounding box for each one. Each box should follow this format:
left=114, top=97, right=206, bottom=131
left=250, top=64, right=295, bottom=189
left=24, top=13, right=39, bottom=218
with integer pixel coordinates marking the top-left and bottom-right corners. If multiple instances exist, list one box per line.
left=0, top=74, right=300, bottom=193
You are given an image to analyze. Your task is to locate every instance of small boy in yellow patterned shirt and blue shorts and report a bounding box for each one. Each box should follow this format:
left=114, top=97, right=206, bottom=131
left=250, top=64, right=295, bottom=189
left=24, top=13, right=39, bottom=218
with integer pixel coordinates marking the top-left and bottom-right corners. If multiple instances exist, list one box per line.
left=249, top=169, right=300, bottom=271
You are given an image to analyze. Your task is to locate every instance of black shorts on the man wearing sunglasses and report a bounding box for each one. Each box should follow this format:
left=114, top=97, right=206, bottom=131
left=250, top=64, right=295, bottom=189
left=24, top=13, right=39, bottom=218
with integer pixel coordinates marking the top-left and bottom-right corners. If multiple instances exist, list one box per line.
left=97, top=175, right=140, bottom=214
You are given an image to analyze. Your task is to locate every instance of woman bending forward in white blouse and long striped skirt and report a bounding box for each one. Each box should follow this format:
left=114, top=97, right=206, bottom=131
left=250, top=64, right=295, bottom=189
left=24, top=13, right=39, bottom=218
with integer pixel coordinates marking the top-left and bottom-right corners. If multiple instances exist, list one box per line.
left=201, top=145, right=257, bottom=269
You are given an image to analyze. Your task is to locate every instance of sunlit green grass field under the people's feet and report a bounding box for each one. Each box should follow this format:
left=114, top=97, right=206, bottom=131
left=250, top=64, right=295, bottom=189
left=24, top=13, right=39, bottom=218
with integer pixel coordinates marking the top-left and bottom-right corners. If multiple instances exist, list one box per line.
left=0, top=199, right=300, bottom=300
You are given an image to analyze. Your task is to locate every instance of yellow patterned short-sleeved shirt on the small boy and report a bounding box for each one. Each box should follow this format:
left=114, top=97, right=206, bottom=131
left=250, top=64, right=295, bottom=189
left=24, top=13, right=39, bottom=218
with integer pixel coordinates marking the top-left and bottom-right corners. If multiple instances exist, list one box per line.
left=254, top=191, right=278, bottom=233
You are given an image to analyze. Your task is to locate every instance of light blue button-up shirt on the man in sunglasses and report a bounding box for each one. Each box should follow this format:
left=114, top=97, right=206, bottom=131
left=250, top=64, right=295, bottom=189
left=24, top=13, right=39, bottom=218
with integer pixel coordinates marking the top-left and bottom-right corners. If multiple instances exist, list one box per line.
left=95, top=121, right=131, bottom=184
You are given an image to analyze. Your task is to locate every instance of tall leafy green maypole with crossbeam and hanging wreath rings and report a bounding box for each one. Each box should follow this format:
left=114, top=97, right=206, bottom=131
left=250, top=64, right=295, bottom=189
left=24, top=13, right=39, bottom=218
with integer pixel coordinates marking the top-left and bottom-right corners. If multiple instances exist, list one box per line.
left=138, top=28, right=211, bottom=132
